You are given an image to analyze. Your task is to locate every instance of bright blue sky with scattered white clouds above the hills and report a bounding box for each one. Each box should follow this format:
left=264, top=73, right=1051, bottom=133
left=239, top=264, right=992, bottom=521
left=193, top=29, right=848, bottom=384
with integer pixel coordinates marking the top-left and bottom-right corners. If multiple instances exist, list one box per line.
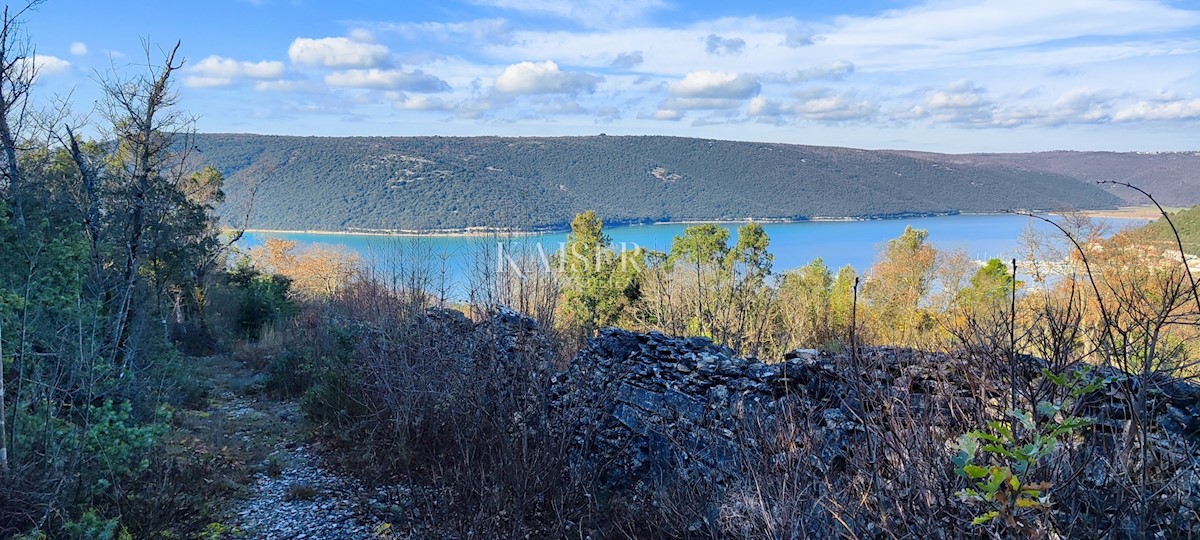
left=14, top=0, right=1200, bottom=152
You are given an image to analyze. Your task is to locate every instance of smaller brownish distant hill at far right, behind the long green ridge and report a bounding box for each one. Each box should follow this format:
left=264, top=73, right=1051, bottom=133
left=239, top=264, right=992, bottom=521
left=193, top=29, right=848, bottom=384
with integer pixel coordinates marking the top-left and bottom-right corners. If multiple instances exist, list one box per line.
left=904, top=151, right=1200, bottom=206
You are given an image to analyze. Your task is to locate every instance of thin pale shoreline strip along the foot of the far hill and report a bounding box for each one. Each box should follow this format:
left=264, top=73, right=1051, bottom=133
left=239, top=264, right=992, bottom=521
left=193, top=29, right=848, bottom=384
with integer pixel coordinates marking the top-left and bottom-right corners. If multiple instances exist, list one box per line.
left=234, top=206, right=1152, bottom=238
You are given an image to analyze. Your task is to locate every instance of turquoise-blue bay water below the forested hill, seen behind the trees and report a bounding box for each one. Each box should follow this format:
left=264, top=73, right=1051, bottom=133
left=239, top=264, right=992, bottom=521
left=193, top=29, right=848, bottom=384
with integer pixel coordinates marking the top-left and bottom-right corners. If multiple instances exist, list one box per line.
left=242, top=215, right=1146, bottom=295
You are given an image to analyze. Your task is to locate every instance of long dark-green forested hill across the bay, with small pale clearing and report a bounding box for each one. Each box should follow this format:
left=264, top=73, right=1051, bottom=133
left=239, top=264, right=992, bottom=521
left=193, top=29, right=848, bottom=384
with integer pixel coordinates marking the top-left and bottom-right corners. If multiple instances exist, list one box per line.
left=194, top=134, right=1121, bottom=230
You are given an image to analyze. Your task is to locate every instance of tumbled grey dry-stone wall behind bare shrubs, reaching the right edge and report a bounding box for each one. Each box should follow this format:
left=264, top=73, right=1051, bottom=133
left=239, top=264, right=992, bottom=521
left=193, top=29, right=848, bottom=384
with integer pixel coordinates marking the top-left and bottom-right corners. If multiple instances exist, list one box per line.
left=552, top=329, right=1200, bottom=532
